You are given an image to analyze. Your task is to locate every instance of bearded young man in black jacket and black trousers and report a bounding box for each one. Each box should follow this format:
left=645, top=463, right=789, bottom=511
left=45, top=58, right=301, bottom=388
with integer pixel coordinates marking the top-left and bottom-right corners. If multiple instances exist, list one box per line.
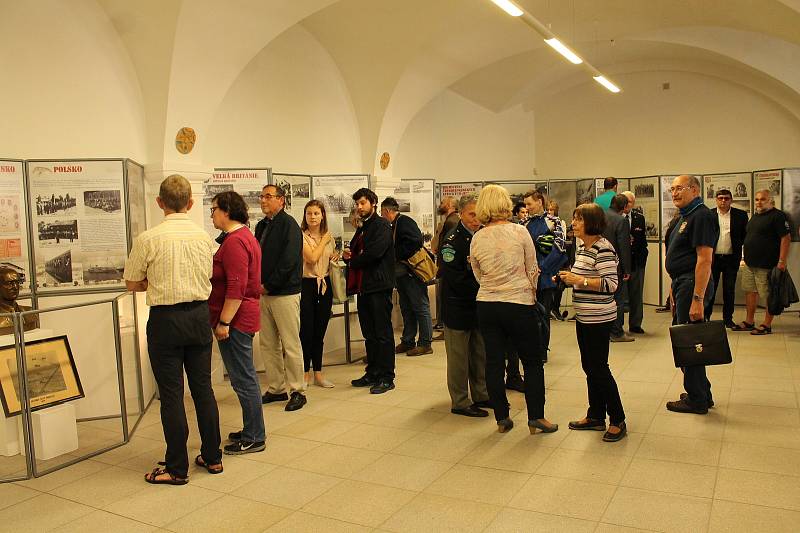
left=342, top=188, right=394, bottom=394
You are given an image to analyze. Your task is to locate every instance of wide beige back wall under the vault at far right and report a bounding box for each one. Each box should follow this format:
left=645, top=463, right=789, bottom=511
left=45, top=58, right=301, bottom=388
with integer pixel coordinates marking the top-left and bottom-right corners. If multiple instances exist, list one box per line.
left=536, top=72, right=800, bottom=177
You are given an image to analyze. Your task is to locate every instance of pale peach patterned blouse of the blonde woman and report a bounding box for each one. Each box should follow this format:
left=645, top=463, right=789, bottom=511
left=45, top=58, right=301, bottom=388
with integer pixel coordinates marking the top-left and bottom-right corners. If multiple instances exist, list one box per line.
left=469, top=224, right=539, bottom=305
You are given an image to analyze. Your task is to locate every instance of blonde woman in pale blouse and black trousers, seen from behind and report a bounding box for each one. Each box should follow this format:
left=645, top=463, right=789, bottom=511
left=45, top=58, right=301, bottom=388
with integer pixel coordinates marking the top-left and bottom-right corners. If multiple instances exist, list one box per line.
left=470, top=185, right=558, bottom=433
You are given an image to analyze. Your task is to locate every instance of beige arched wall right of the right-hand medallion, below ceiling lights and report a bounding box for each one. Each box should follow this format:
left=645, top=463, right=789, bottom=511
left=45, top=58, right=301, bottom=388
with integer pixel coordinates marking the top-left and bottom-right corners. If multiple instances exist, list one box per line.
left=392, top=90, right=535, bottom=181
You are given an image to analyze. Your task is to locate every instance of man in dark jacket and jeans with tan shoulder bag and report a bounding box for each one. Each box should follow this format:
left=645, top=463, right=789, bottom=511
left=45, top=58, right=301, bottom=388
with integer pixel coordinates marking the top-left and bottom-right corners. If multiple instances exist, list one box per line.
left=381, top=196, right=433, bottom=357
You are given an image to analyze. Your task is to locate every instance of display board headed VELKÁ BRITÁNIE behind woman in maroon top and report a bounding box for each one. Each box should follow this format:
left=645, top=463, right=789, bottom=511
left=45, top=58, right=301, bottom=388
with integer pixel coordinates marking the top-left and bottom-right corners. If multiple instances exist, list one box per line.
left=203, top=168, right=270, bottom=238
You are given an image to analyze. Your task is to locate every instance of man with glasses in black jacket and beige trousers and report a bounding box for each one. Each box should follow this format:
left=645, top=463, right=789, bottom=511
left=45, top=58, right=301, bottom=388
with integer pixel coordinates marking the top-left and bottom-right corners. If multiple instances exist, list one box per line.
left=255, top=185, right=306, bottom=411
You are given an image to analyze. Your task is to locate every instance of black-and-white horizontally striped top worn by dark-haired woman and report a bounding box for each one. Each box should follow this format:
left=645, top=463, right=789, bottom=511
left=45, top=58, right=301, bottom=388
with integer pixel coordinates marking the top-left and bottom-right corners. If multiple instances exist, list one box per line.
left=572, top=237, right=619, bottom=324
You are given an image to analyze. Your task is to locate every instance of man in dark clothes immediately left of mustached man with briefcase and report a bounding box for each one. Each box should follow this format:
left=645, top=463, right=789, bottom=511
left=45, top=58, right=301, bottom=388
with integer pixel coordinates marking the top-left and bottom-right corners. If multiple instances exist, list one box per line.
left=622, top=191, right=647, bottom=334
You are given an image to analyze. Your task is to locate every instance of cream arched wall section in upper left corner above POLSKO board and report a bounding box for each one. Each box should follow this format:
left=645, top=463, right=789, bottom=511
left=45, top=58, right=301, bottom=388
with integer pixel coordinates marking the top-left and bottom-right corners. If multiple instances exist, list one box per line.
left=0, top=0, right=145, bottom=160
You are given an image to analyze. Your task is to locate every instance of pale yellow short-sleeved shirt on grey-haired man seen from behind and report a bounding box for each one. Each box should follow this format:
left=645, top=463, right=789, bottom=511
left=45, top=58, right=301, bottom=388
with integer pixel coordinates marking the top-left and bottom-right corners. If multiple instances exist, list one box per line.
left=123, top=213, right=214, bottom=306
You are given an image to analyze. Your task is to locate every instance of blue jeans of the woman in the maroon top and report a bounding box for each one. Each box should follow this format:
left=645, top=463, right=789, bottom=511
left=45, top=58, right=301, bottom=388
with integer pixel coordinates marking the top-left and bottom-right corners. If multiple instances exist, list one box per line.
left=218, top=328, right=266, bottom=442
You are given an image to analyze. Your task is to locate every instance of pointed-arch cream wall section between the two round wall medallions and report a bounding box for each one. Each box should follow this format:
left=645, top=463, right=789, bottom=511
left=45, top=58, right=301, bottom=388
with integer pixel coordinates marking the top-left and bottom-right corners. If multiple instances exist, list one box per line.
left=204, top=27, right=361, bottom=173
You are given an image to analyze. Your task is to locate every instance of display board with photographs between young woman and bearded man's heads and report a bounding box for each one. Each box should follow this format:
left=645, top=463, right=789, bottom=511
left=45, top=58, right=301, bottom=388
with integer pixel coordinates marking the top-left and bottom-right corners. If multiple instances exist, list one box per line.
left=311, top=174, right=369, bottom=250
